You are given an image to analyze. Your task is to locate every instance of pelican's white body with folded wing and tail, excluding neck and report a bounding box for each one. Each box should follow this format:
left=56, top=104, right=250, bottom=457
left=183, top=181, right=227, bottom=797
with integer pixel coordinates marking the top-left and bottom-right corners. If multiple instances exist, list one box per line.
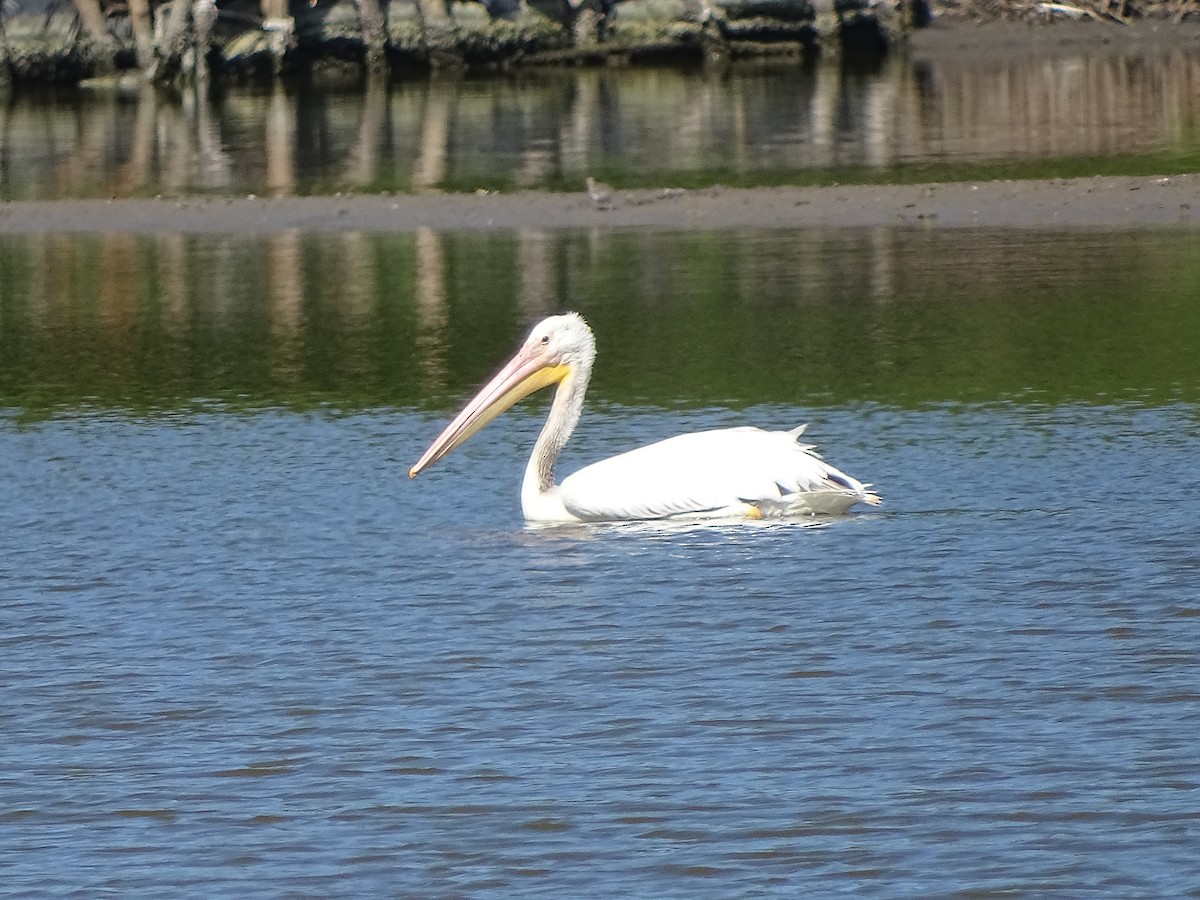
left=559, top=426, right=880, bottom=521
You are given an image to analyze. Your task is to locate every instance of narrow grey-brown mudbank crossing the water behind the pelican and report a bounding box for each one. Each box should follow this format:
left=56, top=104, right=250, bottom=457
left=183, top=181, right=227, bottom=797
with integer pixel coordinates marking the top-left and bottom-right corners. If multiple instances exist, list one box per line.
left=0, top=175, right=1200, bottom=234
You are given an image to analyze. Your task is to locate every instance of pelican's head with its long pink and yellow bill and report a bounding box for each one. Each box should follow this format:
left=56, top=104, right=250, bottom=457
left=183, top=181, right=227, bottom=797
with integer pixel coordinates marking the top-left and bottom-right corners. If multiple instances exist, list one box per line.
left=408, top=312, right=596, bottom=478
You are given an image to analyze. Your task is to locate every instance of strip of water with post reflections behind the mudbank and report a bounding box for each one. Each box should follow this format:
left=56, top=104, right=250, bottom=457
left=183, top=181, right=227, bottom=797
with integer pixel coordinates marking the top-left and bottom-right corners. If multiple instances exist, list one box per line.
left=7, top=42, right=1200, bottom=199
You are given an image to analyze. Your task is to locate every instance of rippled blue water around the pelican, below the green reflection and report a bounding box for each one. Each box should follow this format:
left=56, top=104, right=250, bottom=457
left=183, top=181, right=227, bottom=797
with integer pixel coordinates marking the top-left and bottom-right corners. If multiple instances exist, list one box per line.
left=0, top=403, right=1200, bottom=898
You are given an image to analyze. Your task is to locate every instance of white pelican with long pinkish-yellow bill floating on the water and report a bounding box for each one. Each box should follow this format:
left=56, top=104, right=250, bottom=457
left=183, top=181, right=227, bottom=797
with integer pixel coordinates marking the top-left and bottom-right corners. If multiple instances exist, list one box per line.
left=408, top=312, right=880, bottom=522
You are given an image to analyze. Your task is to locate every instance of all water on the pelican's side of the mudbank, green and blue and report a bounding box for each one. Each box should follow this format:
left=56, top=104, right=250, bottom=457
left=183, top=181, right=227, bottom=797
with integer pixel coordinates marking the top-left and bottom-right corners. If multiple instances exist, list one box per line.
left=0, top=229, right=1200, bottom=898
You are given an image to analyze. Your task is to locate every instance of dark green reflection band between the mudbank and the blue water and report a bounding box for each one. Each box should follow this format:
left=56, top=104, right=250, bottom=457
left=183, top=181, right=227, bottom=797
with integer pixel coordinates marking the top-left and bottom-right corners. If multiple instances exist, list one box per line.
left=0, top=228, right=1200, bottom=416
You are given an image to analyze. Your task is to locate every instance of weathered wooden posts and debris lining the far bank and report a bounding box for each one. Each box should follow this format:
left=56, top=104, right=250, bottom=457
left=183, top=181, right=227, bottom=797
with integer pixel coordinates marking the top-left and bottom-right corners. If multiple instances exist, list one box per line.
left=7, top=0, right=1180, bottom=83
